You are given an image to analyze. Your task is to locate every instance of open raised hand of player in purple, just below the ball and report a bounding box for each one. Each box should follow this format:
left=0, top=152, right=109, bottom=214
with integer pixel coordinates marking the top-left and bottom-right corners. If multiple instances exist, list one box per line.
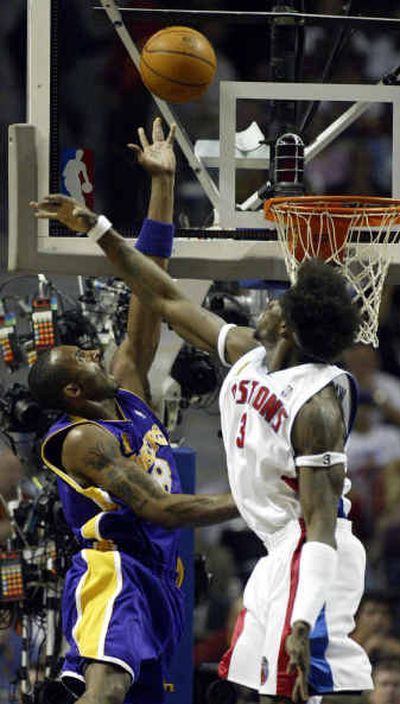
left=128, top=117, right=176, bottom=176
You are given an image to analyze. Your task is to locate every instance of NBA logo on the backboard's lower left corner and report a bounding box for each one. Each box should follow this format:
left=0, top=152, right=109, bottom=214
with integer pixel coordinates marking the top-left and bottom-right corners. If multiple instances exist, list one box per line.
left=61, top=149, right=94, bottom=208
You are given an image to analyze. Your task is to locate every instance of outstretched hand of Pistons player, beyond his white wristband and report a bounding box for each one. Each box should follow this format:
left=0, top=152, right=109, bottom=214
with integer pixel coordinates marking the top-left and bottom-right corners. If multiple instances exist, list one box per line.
left=29, top=193, right=98, bottom=232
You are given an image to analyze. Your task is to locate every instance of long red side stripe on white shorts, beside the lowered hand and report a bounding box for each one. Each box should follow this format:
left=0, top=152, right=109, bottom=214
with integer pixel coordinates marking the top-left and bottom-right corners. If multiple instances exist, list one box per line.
left=276, top=520, right=306, bottom=697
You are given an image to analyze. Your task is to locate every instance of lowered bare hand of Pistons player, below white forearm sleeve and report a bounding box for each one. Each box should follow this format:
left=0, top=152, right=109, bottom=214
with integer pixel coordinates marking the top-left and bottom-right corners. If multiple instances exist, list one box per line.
left=285, top=621, right=310, bottom=702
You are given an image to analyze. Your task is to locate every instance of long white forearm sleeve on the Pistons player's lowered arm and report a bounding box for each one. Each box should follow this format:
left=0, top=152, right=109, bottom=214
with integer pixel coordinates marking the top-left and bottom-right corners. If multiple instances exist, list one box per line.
left=290, top=541, right=338, bottom=629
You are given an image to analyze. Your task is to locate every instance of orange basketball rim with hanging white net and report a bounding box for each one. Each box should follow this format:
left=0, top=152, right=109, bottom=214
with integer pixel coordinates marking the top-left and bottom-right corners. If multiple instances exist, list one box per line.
left=264, top=196, right=400, bottom=347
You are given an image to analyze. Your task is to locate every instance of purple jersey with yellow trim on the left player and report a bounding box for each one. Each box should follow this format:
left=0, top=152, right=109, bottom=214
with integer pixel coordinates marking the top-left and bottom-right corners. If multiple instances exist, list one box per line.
left=42, top=389, right=181, bottom=573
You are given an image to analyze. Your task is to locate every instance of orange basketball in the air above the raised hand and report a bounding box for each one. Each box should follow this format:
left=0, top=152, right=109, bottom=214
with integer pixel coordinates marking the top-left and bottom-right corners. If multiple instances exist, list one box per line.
left=139, top=27, right=217, bottom=103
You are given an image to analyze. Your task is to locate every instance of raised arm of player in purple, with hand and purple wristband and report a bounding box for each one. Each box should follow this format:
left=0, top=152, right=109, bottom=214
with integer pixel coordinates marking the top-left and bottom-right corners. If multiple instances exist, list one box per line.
left=111, top=117, right=176, bottom=403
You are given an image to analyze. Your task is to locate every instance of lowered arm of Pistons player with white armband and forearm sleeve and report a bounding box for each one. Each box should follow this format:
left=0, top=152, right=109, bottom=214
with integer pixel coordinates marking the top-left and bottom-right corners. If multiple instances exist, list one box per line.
left=285, top=386, right=345, bottom=702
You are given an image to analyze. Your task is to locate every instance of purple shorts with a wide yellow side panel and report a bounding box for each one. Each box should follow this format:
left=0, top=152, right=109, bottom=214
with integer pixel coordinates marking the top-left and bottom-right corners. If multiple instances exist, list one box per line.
left=61, top=549, right=184, bottom=704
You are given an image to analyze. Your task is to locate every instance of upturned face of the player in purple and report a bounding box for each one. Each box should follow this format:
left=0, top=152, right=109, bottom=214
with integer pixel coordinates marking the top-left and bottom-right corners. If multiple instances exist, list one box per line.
left=51, top=345, right=118, bottom=401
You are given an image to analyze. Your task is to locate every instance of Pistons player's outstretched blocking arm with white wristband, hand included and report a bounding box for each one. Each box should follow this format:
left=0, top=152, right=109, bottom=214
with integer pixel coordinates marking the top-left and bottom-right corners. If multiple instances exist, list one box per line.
left=31, top=194, right=258, bottom=363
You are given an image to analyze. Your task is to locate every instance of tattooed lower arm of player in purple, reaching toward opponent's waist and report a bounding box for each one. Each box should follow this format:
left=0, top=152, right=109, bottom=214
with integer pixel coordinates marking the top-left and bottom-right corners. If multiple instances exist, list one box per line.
left=62, top=423, right=238, bottom=529
